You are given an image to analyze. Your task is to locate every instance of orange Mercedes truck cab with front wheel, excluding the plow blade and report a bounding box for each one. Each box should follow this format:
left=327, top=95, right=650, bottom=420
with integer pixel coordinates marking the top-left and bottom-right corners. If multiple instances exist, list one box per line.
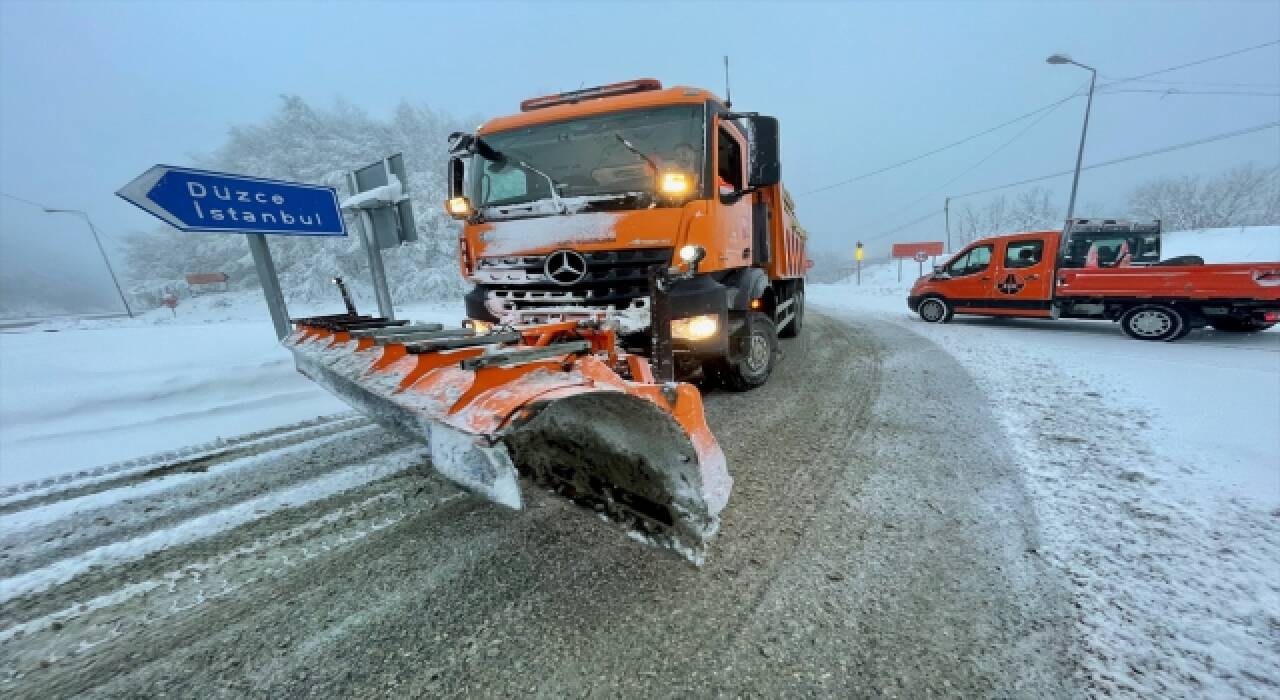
left=445, top=79, right=805, bottom=388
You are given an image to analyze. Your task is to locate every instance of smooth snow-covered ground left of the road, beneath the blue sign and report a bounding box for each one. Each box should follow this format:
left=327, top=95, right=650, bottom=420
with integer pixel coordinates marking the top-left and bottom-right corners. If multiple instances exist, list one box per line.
left=0, top=292, right=463, bottom=488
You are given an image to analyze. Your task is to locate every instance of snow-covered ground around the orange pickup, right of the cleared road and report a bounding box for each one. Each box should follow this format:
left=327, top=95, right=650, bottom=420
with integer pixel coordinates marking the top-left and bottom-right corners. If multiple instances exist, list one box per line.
left=809, top=227, right=1280, bottom=697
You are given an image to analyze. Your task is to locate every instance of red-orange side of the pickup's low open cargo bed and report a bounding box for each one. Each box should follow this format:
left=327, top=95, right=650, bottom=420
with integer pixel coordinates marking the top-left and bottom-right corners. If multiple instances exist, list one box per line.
left=1056, top=262, right=1280, bottom=301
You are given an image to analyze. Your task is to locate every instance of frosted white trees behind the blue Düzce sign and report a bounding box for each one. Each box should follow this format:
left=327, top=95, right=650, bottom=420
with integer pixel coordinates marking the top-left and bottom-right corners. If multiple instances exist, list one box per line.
left=125, top=96, right=476, bottom=307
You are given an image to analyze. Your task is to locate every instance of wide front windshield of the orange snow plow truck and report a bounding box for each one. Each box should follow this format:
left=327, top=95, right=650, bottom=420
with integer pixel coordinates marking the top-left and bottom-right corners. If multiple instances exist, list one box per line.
left=470, top=105, right=704, bottom=206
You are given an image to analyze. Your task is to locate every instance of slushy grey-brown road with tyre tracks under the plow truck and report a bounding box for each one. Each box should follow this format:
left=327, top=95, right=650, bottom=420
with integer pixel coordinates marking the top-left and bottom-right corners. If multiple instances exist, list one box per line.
left=0, top=315, right=1070, bottom=697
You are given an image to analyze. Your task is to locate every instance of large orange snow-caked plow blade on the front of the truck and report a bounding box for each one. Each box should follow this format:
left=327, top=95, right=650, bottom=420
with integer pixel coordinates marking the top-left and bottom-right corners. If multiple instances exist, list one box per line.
left=284, top=315, right=732, bottom=564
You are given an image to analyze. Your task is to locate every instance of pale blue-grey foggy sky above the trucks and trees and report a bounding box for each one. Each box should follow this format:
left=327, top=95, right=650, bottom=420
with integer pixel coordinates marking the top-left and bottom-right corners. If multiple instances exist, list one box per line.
left=0, top=0, right=1280, bottom=310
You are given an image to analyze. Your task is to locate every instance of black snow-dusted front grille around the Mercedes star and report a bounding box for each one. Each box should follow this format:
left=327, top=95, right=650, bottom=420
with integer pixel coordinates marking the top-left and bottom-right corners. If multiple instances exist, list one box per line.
left=474, top=248, right=672, bottom=310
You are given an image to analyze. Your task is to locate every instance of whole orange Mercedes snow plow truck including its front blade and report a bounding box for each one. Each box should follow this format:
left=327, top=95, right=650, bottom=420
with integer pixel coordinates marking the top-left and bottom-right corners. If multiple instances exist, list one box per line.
left=285, top=79, right=806, bottom=563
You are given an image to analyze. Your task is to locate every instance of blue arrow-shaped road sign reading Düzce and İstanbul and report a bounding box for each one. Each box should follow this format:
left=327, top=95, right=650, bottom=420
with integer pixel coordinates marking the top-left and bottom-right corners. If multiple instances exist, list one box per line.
left=116, top=165, right=347, bottom=235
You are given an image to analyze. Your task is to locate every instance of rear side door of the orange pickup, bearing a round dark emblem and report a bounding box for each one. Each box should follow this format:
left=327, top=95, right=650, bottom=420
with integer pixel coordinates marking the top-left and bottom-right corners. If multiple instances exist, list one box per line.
left=986, top=237, right=1053, bottom=316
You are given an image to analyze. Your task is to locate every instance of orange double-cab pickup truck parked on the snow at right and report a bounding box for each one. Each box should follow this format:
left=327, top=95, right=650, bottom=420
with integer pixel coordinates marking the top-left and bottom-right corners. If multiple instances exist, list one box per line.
left=908, top=219, right=1280, bottom=340
